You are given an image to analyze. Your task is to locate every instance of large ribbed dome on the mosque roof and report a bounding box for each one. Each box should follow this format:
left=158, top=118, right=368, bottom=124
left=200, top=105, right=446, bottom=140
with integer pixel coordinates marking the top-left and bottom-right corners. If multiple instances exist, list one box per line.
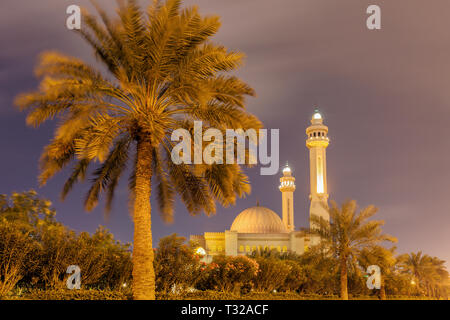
left=230, top=206, right=288, bottom=233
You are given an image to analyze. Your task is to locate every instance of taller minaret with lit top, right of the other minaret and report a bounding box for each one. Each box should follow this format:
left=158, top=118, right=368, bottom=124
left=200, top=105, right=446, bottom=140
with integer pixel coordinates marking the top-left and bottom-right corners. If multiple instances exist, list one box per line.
left=306, top=109, right=330, bottom=231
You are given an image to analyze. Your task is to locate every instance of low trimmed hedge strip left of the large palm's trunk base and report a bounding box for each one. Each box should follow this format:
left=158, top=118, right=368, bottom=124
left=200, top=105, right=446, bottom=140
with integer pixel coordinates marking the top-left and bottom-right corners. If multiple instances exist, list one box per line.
left=18, top=289, right=130, bottom=300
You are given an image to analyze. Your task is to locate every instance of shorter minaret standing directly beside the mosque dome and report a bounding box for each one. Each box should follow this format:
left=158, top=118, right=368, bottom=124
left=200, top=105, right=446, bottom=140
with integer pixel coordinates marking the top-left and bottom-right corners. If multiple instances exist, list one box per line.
left=279, top=165, right=295, bottom=231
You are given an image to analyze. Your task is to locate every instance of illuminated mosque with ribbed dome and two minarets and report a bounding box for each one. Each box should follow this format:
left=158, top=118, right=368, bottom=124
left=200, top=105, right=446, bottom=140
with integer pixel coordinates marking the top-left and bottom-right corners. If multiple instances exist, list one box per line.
left=190, top=109, right=329, bottom=261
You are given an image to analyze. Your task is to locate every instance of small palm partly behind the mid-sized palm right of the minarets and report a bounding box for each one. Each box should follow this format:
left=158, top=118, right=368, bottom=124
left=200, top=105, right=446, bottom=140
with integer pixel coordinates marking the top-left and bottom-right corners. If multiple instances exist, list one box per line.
left=358, top=245, right=397, bottom=300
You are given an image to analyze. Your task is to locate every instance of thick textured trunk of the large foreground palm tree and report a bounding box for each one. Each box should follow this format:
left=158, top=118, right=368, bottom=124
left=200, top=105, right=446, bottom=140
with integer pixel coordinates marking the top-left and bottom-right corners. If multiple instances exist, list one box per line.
left=133, top=137, right=155, bottom=300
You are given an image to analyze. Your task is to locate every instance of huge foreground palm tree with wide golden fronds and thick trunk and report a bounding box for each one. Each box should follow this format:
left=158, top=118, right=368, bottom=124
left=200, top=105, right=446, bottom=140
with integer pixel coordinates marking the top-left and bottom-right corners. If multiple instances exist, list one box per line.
left=16, top=0, right=261, bottom=299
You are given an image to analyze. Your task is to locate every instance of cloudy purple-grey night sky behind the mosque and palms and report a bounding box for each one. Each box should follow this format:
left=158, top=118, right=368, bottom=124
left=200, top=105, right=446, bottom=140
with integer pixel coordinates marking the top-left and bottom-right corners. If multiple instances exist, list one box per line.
left=0, top=0, right=450, bottom=266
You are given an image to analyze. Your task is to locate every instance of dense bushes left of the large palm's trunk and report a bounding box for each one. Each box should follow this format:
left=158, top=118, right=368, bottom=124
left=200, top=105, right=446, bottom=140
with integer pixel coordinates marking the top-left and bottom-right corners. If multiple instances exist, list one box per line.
left=0, top=191, right=132, bottom=296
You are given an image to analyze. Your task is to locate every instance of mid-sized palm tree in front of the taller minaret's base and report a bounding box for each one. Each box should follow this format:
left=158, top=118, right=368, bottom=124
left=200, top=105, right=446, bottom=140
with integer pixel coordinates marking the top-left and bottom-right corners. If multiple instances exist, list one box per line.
left=307, top=200, right=397, bottom=300
